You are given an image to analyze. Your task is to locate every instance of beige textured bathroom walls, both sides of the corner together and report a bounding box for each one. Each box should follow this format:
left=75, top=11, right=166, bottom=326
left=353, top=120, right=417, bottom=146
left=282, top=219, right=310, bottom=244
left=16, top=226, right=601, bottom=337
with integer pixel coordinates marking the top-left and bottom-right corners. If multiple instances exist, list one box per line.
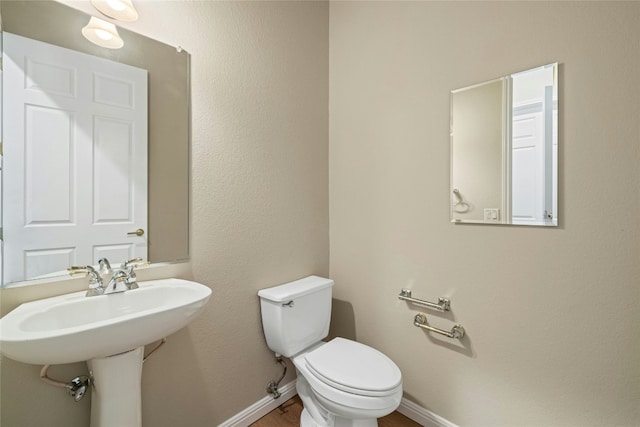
left=1, top=2, right=640, bottom=427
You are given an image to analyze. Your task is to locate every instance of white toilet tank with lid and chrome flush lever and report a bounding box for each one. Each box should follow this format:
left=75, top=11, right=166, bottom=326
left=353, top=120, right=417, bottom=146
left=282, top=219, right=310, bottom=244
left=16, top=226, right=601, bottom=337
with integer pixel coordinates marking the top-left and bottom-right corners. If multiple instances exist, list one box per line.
left=258, top=276, right=333, bottom=357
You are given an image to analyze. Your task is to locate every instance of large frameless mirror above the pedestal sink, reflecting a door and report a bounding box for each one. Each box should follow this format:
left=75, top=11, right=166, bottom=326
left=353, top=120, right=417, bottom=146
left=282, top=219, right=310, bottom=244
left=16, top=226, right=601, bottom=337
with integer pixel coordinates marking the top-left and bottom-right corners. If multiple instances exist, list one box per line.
left=0, top=1, right=190, bottom=286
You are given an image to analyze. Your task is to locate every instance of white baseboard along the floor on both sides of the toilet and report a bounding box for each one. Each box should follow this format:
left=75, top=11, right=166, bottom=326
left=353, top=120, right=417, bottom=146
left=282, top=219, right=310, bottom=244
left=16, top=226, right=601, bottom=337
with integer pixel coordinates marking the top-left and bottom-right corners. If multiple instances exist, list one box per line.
left=218, top=380, right=458, bottom=427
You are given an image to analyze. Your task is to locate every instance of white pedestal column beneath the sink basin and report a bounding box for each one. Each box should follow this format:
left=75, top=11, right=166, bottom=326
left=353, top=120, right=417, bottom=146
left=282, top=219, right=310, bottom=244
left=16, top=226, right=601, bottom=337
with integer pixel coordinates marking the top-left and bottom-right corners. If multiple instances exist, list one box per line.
left=87, top=347, right=144, bottom=427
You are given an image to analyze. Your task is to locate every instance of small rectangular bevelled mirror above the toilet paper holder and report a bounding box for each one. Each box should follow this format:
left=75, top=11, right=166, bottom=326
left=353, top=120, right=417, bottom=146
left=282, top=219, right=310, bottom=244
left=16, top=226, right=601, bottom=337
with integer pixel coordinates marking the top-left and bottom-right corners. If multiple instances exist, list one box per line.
left=450, top=63, right=558, bottom=226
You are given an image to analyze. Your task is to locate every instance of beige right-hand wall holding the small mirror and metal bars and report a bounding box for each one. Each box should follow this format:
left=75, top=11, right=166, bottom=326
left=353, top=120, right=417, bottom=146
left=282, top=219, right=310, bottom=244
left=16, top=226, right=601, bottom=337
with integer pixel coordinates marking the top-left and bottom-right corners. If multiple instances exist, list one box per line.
left=329, top=2, right=640, bottom=427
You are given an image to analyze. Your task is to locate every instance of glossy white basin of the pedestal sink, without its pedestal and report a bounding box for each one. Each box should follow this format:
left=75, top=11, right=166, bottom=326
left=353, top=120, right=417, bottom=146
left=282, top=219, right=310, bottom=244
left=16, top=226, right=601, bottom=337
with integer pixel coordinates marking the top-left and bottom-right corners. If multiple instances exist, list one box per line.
left=0, top=279, right=211, bottom=365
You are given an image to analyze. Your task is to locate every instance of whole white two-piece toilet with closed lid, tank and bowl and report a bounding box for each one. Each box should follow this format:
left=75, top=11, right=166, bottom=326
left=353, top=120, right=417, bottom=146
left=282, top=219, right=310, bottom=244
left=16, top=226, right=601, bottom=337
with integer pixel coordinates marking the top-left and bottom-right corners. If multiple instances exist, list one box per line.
left=258, top=276, right=402, bottom=427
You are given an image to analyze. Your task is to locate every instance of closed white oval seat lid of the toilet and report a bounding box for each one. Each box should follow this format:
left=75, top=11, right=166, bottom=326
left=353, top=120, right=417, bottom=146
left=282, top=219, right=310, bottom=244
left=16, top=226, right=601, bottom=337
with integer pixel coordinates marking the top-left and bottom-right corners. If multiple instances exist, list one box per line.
left=304, top=338, right=402, bottom=397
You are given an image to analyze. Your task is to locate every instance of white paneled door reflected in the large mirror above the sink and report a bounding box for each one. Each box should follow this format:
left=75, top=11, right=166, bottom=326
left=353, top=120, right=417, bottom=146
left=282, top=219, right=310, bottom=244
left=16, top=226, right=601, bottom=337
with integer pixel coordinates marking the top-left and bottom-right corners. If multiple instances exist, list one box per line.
left=2, top=32, right=148, bottom=283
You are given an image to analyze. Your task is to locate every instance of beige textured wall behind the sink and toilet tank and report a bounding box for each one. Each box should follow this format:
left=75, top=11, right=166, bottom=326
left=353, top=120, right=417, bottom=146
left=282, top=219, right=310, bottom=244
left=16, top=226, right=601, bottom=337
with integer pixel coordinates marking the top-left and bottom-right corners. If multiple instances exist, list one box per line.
left=0, top=1, right=329, bottom=427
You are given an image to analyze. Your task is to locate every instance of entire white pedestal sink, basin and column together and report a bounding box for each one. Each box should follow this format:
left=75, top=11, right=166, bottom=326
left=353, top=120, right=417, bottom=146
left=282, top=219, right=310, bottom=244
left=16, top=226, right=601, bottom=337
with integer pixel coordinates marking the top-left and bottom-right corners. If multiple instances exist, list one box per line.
left=0, top=279, right=211, bottom=427
